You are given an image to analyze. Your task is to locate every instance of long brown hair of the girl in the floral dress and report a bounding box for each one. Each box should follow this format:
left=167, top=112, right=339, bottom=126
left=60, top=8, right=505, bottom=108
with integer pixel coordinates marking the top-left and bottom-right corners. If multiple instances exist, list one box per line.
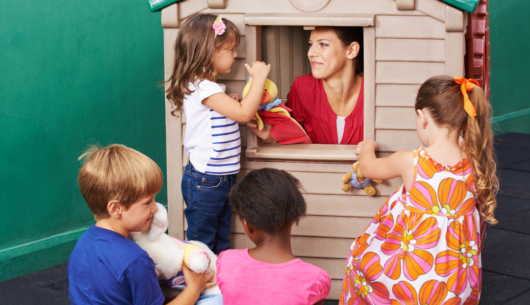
left=415, top=76, right=499, bottom=224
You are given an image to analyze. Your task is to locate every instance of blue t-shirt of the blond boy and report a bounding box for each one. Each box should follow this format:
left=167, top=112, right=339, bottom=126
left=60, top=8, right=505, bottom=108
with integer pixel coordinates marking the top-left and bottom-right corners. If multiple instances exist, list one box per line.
left=68, top=226, right=164, bottom=305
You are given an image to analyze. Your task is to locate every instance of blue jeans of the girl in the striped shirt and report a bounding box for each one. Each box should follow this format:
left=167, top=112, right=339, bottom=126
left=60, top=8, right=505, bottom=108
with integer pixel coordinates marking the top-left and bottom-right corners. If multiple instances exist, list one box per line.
left=181, top=162, right=237, bottom=255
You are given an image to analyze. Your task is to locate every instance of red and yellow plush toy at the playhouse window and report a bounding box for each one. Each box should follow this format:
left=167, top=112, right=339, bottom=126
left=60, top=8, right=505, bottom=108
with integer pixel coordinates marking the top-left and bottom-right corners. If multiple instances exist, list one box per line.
left=242, top=79, right=311, bottom=144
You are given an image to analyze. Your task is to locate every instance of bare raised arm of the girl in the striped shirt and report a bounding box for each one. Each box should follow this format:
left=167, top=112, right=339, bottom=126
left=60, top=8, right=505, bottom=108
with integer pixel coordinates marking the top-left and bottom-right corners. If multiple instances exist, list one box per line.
left=202, top=61, right=271, bottom=122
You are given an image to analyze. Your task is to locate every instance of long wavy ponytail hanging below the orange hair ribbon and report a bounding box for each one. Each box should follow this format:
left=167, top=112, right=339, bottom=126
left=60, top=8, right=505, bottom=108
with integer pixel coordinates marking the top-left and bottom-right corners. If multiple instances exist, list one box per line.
left=463, top=86, right=499, bottom=224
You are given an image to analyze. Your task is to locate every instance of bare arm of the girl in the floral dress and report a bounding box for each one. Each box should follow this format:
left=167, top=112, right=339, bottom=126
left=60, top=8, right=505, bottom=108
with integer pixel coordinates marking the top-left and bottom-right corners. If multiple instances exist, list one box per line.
left=355, top=140, right=414, bottom=186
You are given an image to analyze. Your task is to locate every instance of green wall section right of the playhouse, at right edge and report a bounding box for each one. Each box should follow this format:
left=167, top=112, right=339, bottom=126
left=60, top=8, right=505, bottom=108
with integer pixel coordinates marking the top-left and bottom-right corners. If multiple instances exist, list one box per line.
left=488, top=0, right=530, bottom=134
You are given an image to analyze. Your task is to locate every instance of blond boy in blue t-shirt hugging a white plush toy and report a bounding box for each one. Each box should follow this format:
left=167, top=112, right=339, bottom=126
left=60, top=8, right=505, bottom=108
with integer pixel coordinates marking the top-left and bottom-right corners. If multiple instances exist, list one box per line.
left=68, top=145, right=211, bottom=304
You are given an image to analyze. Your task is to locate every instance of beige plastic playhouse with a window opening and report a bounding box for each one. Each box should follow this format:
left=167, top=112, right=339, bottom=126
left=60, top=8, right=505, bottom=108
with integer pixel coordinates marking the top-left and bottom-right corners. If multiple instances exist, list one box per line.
left=162, top=0, right=489, bottom=299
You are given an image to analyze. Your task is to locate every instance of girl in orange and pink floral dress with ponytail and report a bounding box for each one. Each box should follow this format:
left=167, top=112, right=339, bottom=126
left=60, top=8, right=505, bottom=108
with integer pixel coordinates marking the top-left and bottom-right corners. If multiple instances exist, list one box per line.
left=340, top=76, right=498, bottom=305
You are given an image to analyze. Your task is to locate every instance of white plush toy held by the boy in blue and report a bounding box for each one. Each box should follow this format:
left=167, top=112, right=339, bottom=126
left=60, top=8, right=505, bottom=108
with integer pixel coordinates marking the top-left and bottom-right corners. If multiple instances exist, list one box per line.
left=129, top=203, right=221, bottom=295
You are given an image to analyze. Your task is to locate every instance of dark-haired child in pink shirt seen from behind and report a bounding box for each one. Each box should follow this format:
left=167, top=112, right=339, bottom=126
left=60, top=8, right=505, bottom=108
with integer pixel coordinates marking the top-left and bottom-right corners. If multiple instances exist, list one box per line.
left=216, top=168, right=331, bottom=305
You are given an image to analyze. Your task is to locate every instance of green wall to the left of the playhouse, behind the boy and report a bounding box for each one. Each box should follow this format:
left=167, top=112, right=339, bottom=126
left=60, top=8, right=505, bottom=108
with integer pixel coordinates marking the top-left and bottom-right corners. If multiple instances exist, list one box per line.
left=0, top=0, right=167, bottom=281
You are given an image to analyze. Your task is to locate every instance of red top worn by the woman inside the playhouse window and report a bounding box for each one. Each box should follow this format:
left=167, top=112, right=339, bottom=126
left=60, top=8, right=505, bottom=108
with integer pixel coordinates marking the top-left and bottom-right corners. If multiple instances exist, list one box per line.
left=286, top=73, right=364, bottom=145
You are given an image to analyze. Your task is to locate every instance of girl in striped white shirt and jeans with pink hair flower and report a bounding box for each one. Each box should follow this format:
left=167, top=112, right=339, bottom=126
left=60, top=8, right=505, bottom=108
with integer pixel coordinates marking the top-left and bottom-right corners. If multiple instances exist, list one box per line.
left=167, top=15, right=270, bottom=254
